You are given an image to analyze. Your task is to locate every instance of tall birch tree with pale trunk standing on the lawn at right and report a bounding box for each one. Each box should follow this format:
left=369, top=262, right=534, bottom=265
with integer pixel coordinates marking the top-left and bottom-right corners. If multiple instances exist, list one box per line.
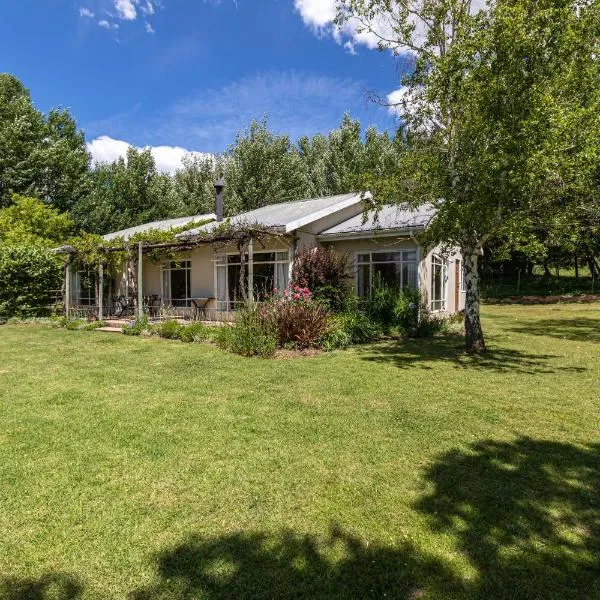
left=338, top=0, right=598, bottom=352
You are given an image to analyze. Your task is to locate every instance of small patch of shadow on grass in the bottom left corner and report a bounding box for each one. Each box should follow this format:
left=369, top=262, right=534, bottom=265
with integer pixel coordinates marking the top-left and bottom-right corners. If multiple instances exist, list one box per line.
left=0, top=573, right=84, bottom=600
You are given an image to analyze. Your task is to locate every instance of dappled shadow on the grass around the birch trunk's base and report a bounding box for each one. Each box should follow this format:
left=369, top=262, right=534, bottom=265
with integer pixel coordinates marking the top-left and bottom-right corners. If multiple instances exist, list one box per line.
left=357, top=336, right=586, bottom=375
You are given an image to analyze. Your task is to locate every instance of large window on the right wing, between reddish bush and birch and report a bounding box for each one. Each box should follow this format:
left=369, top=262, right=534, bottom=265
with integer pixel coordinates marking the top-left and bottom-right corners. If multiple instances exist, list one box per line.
left=356, top=250, right=418, bottom=298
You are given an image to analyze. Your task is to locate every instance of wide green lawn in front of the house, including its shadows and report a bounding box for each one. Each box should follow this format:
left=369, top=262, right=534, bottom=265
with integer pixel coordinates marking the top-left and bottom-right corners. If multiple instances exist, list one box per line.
left=0, top=305, right=600, bottom=600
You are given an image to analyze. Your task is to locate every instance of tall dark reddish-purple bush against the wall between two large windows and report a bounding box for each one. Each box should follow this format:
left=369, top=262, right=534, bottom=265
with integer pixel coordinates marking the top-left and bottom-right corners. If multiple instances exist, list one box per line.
left=292, top=246, right=351, bottom=312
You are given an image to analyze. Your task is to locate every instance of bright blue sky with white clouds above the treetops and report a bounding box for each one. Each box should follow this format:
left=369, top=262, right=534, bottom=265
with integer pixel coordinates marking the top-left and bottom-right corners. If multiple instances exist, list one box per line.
left=0, top=0, right=410, bottom=172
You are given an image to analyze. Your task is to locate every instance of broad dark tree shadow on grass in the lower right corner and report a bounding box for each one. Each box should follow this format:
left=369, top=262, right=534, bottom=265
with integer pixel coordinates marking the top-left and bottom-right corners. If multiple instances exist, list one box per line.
left=417, top=438, right=600, bottom=600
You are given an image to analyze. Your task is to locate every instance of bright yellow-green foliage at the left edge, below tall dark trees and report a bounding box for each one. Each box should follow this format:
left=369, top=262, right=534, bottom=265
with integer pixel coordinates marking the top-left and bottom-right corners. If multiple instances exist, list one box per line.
left=0, top=194, right=73, bottom=248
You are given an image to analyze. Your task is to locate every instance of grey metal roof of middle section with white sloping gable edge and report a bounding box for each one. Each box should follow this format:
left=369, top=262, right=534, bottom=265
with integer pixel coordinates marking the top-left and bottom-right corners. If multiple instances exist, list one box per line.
left=177, top=192, right=362, bottom=237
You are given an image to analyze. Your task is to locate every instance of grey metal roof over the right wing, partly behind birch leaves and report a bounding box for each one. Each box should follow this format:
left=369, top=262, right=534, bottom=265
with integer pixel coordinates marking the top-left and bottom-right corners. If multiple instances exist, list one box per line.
left=320, top=204, right=435, bottom=237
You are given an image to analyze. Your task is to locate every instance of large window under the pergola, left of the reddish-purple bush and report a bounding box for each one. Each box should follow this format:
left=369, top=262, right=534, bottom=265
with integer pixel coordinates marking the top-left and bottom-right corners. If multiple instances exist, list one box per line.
left=216, top=251, right=289, bottom=310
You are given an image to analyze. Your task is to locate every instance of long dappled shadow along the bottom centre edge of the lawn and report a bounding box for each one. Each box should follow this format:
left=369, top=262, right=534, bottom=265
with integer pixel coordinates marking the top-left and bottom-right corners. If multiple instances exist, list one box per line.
left=128, top=528, right=462, bottom=600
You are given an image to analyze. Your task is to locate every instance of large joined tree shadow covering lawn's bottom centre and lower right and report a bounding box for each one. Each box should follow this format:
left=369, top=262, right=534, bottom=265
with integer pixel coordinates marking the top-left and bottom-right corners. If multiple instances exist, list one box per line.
left=128, top=438, right=600, bottom=600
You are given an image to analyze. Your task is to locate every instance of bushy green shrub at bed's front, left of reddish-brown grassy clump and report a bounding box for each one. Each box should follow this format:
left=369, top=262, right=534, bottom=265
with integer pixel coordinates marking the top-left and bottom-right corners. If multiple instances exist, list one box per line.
left=215, top=305, right=277, bottom=358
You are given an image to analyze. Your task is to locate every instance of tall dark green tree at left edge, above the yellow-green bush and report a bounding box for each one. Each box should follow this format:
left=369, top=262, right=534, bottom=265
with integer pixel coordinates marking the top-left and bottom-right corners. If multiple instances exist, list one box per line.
left=0, top=73, right=89, bottom=211
